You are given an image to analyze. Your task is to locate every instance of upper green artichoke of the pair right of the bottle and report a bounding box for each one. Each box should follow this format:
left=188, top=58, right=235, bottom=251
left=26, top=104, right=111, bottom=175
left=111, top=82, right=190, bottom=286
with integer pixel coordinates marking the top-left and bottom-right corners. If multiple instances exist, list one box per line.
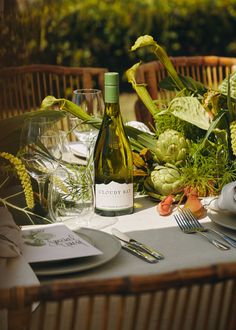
left=155, top=129, right=189, bottom=166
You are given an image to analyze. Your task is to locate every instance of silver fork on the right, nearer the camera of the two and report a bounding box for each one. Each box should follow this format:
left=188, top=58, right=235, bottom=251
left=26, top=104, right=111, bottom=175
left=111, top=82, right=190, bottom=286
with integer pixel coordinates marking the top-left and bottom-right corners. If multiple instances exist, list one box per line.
left=174, top=212, right=230, bottom=250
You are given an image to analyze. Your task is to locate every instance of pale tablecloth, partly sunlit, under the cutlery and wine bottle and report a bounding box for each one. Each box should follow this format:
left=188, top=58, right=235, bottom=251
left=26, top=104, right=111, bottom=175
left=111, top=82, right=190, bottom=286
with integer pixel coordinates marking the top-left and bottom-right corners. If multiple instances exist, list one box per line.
left=1, top=198, right=236, bottom=286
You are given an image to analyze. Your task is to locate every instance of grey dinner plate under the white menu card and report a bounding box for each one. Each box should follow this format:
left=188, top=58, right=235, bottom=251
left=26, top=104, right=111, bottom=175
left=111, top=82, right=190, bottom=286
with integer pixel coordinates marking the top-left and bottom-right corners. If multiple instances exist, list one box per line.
left=31, top=228, right=121, bottom=276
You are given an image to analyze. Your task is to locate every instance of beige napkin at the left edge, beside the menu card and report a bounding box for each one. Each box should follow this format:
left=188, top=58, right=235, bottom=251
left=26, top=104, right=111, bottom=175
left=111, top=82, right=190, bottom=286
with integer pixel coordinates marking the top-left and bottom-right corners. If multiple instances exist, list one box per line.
left=0, top=207, right=23, bottom=258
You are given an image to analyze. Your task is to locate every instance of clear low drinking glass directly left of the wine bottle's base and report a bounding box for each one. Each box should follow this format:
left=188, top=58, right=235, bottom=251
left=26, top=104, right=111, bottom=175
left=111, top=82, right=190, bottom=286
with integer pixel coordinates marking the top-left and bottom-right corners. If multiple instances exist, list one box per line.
left=49, top=164, right=117, bottom=230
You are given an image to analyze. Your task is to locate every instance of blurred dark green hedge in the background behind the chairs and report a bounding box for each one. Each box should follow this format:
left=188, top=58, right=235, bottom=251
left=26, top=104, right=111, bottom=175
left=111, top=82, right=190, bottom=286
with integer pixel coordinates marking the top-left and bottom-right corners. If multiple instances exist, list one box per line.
left=0, top=0, right=236, bottom=91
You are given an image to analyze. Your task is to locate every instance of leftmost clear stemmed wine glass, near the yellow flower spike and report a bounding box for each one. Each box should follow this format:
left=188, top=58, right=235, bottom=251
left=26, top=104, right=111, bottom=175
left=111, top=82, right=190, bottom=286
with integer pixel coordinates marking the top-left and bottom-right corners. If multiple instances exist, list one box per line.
left=20, top=117, right=62, bottom=213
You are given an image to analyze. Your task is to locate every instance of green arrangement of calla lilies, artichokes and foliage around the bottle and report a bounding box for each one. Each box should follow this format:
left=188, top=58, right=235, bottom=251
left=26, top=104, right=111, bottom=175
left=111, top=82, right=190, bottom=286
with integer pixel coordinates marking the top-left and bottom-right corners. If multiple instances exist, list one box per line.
left=0, top=35, right=236, bottom=219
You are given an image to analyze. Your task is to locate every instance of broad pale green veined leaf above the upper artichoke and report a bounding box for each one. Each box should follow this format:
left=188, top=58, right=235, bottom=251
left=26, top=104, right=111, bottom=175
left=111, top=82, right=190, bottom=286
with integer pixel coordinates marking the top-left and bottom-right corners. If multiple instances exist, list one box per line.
left=167, top=96, right=211, bottom=130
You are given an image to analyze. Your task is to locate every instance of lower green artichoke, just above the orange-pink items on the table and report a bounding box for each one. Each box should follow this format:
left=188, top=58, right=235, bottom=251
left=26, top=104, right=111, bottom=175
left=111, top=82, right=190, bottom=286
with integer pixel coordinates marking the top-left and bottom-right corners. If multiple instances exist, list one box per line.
left=144, top=164, right=183, bottom=198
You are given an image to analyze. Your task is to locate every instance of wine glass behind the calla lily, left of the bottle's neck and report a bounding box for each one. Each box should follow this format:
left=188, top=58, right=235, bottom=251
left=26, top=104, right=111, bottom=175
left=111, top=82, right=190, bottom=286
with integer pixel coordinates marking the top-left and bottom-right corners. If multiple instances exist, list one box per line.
left=70, top=89, right=103, bottom=159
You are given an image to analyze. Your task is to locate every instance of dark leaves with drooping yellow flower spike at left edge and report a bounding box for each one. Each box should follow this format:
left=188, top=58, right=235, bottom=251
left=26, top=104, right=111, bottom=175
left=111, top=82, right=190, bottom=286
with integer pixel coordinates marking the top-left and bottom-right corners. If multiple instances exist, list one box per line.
left=0, top=110, right=65, bottom=224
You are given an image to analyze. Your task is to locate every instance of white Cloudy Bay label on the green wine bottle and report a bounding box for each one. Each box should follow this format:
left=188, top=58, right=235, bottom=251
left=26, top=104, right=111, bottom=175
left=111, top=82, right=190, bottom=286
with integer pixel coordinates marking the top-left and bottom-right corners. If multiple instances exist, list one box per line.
left=95, top=181, right=133, bottom=210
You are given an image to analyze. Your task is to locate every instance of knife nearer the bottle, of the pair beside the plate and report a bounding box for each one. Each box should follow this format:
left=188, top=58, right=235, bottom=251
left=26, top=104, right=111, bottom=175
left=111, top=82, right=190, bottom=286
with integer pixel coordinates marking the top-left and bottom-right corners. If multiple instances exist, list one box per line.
left=111, top=228, right=164, bottom=260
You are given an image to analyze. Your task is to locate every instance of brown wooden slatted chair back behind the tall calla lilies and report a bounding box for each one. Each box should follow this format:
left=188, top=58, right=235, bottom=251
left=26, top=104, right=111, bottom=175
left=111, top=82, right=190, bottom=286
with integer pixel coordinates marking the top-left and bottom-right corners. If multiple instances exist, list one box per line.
left=135, top=56, right=236, bottom=123
